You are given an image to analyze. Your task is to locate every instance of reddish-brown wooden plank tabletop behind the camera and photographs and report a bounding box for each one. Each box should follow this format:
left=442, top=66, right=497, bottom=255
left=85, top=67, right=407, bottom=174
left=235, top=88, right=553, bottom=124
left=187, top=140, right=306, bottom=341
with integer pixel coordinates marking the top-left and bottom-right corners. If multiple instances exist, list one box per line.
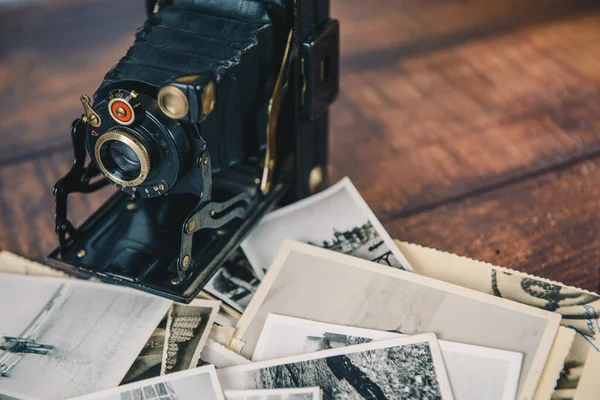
left=0, top=0, right=600, bottom=290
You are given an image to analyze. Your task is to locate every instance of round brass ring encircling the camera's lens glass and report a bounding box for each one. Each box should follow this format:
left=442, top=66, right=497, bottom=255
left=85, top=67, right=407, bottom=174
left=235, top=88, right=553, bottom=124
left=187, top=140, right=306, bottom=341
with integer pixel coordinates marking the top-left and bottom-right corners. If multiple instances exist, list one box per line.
left=94, top=130, right=150, bottom=186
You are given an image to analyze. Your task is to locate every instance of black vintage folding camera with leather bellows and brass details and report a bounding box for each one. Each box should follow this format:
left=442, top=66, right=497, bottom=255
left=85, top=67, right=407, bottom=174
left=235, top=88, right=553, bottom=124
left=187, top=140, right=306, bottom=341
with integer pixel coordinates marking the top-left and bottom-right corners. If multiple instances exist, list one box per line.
left=49, top=0, right=339, bottom=302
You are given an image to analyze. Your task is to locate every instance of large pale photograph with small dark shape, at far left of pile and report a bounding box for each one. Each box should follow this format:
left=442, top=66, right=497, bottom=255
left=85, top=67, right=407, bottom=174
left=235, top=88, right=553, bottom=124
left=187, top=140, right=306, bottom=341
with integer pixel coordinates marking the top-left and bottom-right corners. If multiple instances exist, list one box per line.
left=0, top=274, right=171, bottom=400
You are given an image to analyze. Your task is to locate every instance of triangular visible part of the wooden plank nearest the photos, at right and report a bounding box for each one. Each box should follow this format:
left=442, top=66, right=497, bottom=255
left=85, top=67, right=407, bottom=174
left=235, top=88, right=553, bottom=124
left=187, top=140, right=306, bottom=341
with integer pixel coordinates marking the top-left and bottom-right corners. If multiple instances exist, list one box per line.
left=384, top=158, right=600, bottom=291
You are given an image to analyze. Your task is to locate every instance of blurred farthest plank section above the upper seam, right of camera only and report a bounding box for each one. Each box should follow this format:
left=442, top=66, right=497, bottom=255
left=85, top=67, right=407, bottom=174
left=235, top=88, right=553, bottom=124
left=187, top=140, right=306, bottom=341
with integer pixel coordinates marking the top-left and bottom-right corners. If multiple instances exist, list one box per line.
left=331, top=0, right=598, bottom=64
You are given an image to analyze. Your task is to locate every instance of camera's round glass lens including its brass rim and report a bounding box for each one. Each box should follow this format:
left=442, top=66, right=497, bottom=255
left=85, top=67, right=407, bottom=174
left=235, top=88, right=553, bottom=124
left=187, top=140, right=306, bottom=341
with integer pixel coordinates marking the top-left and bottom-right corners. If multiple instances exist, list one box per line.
left=95, top=130, right=150, bottom=186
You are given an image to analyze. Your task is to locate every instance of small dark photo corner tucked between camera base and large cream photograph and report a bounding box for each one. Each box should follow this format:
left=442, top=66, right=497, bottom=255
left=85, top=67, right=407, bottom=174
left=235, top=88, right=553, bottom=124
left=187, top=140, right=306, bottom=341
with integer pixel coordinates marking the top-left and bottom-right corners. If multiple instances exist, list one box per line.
left=204, top=248, right=260, bottom=312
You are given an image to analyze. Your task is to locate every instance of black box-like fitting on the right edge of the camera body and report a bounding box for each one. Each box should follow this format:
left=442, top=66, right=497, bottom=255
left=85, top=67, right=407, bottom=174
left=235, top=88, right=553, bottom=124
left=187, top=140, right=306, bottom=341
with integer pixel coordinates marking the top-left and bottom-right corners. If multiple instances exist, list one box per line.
left=302, top=19, right=340, bottom=121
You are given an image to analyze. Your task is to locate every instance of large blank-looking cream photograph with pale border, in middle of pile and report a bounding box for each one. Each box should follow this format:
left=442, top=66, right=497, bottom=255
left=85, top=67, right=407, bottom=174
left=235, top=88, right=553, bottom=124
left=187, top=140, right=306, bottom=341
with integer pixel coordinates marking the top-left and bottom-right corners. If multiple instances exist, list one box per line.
left=236, top=241, right=560, bottom=398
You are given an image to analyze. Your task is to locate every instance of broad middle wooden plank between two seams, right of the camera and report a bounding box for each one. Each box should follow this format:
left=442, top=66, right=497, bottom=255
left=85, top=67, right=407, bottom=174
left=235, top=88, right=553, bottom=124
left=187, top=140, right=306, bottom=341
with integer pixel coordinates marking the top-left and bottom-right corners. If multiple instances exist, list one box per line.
left=331, top=14, right=600, bottom=219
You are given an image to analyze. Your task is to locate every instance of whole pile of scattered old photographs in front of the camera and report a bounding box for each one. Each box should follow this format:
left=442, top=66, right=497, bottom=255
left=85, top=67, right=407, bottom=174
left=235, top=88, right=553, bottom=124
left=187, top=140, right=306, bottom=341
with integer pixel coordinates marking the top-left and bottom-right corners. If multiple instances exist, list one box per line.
left=0, top=178, right=600, bottom=400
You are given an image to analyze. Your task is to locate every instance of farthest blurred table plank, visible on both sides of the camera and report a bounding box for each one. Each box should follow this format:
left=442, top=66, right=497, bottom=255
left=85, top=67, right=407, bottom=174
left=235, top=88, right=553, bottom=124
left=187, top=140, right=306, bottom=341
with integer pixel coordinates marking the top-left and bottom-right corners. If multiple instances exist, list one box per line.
left=0, top=0, right=593, bottom=163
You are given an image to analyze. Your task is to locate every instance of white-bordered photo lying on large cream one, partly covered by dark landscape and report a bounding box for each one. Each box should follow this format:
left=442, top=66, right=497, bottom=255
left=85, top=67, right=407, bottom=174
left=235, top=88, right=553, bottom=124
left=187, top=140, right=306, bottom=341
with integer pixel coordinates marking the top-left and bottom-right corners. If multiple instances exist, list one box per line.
left=252, top=314, right=523, bottom=400
